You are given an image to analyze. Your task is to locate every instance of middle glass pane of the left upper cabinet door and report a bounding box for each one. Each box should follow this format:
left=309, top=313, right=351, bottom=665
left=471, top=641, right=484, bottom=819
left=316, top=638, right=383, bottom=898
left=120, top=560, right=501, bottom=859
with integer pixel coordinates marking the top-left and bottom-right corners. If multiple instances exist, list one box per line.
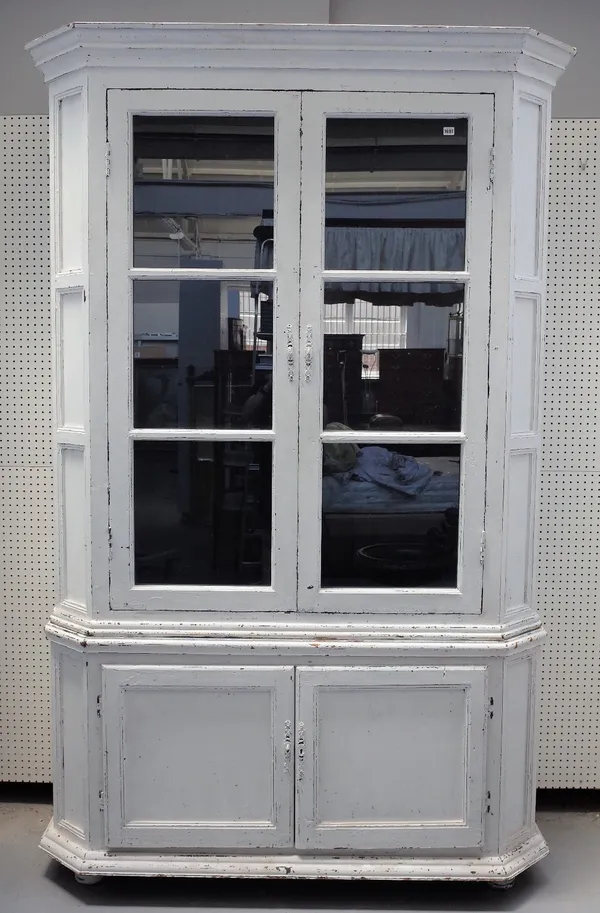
left=133, top=280, right=273, bottom=428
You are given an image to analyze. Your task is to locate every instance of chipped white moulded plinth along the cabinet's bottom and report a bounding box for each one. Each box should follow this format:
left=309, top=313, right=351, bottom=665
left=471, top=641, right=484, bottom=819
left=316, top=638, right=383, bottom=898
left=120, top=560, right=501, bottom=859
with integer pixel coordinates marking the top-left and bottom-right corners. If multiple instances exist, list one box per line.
left=40, top=822, right=548, bottom=885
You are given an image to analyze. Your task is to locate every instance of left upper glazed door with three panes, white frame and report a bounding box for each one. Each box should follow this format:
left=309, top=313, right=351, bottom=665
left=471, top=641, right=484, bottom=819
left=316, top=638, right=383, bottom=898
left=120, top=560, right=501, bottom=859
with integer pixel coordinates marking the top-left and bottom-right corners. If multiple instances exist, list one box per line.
left=108, top=90, right=300, bottom=611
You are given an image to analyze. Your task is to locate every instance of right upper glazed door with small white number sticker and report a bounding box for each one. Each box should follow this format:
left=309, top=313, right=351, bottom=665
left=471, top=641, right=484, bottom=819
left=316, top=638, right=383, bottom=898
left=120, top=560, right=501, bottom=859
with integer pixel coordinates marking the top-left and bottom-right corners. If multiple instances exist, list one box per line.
left=299, top=93, right=493, bottom=613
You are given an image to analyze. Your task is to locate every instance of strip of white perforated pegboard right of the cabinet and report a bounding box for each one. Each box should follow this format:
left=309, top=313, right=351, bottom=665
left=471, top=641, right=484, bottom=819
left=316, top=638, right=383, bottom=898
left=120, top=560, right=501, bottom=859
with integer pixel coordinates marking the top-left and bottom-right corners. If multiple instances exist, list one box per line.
left=538, top=119, right=600, bottom=789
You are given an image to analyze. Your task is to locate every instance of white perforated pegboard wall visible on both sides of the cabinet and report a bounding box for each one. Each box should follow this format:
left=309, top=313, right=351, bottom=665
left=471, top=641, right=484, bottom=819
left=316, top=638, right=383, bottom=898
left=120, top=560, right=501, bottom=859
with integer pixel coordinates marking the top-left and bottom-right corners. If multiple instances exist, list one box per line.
left=0, top=116, right=600, bottom=788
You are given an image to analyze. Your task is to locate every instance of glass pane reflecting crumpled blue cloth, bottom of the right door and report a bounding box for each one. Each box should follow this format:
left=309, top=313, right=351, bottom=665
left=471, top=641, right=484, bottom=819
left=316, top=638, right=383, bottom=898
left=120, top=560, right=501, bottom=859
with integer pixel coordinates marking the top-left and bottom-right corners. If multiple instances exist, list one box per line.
left=321, top=443, right=461, bottom=588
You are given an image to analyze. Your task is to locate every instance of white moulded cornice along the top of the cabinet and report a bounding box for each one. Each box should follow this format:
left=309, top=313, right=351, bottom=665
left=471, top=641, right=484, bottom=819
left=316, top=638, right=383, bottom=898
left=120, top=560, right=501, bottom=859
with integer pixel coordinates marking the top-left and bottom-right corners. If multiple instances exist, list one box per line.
left=26, top=22, right=575, bottom=85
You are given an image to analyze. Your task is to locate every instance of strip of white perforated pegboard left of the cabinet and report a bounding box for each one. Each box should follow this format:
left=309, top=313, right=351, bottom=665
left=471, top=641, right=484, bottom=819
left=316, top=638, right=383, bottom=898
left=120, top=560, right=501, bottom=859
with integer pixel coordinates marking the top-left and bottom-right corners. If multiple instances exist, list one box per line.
left=0, top=116, right=55, bottom=782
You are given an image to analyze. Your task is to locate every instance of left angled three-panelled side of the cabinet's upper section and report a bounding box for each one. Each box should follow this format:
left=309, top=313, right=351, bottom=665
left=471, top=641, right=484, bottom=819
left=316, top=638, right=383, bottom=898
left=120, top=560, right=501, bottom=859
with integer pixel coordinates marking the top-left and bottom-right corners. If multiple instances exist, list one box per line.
left=50, top=80, right=91, bottom=615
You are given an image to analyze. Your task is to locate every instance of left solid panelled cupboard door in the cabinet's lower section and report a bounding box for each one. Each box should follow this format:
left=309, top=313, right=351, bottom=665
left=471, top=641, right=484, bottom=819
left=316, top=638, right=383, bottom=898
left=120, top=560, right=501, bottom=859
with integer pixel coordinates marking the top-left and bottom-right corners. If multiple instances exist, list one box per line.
left=102, top=665, right=294, bottom=850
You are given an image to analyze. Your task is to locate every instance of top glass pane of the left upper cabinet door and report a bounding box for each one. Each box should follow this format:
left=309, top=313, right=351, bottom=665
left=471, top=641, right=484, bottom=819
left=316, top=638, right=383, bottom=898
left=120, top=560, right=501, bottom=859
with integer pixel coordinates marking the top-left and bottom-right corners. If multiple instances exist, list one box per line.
left=133, top=115, right=274, bottom=269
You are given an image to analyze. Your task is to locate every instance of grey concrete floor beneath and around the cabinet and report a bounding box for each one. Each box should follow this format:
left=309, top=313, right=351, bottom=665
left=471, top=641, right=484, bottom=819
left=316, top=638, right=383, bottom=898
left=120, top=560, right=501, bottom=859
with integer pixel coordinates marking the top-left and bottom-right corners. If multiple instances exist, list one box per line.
left=0, top=790, right=600, bottom=913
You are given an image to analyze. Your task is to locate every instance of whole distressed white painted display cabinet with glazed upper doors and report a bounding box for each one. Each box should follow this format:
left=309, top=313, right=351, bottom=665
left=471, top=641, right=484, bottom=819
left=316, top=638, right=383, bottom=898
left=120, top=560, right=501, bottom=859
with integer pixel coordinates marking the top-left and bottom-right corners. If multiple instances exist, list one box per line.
left=29, top=23, right=572, bottom=884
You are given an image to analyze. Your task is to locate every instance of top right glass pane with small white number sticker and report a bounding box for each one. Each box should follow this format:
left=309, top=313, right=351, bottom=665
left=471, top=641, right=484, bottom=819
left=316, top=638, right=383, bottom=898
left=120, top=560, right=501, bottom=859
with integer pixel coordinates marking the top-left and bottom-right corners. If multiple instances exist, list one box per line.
left=325, top=117, right=468, bottom=270
